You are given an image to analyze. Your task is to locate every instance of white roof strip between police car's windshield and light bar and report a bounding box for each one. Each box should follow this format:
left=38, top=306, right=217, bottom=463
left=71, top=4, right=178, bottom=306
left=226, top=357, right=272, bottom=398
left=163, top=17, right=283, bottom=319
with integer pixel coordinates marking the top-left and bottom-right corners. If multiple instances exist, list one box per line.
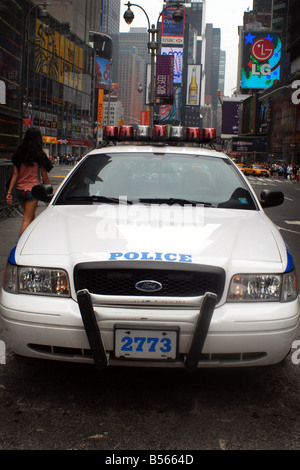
left=87, top=145, right=231, bottom=161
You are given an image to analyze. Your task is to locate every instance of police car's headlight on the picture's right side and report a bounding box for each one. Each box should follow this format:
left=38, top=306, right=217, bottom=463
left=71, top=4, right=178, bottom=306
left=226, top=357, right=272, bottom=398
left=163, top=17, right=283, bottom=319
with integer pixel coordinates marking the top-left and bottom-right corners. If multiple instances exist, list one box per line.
left=228, top=271, right=298, bottom=302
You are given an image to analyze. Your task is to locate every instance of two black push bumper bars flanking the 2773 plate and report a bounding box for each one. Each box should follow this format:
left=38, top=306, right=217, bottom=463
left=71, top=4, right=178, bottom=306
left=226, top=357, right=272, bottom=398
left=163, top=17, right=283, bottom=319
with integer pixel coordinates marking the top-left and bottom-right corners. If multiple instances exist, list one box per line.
left=77, top=289, right=217, bottom=372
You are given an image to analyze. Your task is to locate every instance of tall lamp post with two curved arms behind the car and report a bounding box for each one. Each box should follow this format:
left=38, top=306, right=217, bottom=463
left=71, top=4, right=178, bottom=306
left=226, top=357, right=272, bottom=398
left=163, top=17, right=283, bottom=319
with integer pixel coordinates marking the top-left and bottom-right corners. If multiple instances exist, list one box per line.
left=123, top=2, right=183, bottom=133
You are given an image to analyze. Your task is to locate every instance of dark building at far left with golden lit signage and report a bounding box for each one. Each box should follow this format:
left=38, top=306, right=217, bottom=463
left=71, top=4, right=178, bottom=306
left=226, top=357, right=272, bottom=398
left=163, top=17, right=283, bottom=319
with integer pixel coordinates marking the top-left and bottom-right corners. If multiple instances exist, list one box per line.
left=0, top=0, right=95, bottom=159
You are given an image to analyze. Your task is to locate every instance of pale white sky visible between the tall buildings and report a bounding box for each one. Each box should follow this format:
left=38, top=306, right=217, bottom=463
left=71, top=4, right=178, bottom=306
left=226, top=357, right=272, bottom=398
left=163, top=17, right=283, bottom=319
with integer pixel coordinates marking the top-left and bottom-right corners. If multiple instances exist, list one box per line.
left=120, top=0, right=253, bottom=96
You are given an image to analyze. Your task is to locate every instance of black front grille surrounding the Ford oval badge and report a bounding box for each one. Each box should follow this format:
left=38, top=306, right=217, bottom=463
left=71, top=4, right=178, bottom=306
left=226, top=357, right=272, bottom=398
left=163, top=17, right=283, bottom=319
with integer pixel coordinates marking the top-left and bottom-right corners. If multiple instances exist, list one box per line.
left=74, top=265, right=225, bottom=300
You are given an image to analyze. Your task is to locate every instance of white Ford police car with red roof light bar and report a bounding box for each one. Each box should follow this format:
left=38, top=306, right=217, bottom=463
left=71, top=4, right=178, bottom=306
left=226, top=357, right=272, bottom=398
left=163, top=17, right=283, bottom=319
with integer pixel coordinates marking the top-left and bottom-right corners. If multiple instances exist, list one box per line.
left=1, top=126, right=299, bottom=371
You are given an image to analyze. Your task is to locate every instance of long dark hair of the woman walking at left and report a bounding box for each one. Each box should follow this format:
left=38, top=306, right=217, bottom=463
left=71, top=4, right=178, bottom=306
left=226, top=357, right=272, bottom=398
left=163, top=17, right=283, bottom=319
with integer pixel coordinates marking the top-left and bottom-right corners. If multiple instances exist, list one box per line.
left=12, top=127, right=52, bottom=171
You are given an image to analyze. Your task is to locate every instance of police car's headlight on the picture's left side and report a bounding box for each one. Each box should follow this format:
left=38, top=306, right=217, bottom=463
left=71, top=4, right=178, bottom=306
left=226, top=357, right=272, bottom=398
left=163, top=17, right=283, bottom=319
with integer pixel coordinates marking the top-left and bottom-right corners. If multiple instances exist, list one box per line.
left=3, top=264, right=70, bottom=297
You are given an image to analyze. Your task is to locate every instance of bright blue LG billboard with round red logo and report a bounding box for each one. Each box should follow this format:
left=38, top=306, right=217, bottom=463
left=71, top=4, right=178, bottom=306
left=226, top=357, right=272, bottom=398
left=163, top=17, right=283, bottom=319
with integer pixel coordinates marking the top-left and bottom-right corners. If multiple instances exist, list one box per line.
left=241, top=31, right=282, bottom=89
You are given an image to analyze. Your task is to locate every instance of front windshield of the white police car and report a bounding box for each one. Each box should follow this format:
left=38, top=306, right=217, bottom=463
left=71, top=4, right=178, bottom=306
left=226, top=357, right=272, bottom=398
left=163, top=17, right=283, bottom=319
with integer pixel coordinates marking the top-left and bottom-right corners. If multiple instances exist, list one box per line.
left=55, top=151, right=256, bottom=209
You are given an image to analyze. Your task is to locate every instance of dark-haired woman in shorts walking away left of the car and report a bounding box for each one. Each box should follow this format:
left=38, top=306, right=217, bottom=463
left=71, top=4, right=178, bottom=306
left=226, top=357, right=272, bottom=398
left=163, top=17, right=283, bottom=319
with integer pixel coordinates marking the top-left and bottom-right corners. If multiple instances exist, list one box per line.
left=6, top=128, right=53, bottom=235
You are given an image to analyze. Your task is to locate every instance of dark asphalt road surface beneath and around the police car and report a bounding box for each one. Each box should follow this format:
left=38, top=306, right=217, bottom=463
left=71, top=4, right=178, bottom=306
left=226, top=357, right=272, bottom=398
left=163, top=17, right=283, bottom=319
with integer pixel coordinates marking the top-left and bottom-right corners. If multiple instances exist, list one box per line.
left=0, top=167, right=300, bottom=454
